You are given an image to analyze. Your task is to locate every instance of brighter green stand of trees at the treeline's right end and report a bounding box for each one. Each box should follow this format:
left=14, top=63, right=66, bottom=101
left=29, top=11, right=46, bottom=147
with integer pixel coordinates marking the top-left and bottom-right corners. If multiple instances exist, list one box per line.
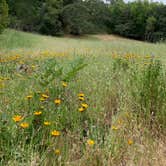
left=110, top=1, right=166, bottom=42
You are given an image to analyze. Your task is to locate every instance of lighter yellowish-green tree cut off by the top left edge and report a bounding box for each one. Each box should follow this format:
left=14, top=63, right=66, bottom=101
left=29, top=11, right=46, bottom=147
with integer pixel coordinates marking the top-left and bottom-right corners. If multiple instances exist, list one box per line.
left=0, top=0, right=8, bottom=33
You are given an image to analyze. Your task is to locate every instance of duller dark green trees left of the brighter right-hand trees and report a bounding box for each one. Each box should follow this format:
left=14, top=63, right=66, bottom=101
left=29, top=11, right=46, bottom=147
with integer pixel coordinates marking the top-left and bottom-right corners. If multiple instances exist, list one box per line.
left=7, top=0, right=110, bottom=35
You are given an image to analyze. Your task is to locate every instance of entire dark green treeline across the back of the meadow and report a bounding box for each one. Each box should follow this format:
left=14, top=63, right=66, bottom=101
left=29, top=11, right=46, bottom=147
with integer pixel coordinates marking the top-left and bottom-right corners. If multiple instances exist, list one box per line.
left=0, top=0, right=166, bottom=42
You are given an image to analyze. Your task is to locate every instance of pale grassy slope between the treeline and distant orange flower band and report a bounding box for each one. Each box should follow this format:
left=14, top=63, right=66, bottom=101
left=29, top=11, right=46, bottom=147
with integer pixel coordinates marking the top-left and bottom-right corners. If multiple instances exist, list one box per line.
left=0, top=30, right=166, bottom=56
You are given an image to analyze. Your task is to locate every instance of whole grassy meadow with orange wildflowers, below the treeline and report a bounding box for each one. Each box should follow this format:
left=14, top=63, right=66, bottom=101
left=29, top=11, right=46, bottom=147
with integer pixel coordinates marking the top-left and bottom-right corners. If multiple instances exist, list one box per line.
left=0, top=29, right=166, bottom=166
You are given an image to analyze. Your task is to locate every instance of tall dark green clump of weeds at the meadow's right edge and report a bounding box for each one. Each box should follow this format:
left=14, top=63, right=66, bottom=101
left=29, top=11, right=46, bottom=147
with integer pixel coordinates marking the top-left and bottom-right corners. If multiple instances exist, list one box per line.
left=131, top=59, right=166, bottom=131
